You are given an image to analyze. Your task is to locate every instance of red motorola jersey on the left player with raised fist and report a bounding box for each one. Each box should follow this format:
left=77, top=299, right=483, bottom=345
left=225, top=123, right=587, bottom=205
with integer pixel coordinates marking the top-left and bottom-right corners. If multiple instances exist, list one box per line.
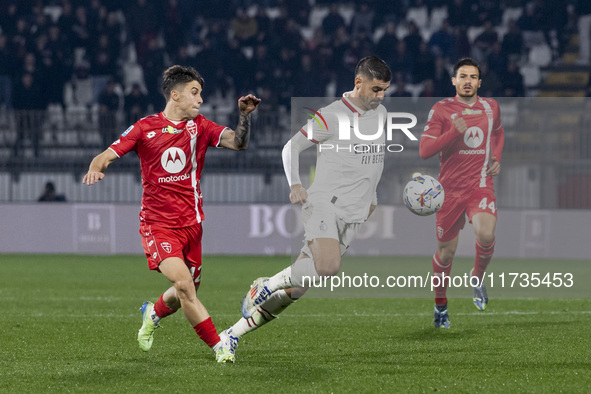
left=110, top=112, right=226, bottom=228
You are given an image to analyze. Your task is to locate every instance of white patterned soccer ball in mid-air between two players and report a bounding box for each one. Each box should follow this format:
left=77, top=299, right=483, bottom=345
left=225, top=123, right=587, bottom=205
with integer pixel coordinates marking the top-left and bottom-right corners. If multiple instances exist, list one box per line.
left=404, top=174, right=445, bottom=216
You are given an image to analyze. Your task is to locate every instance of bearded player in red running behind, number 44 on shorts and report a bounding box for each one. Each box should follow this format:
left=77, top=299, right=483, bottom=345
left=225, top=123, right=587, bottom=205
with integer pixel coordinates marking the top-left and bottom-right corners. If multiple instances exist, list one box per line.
left=419, top=58, right=504, bottom=328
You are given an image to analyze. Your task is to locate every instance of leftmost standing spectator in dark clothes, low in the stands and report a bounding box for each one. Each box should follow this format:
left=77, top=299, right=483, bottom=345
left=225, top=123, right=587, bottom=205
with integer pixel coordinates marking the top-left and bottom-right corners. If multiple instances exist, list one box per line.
left=12, top=73, right=47, bottom=157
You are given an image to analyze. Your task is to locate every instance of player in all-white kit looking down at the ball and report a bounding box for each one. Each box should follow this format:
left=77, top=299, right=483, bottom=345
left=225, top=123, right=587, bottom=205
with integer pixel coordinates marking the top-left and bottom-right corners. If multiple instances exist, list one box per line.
left=217, top=56, right=391, bottom=360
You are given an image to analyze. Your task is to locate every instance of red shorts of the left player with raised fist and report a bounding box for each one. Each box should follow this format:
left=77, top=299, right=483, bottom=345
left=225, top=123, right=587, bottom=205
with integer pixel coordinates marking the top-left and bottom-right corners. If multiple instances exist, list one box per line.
left=140, top=224, right=203, bottom=287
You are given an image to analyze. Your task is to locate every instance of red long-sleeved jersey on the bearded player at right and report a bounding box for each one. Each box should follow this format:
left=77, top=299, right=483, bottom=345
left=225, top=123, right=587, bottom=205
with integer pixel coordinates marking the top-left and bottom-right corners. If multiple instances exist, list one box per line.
left=419, top=97, right=504, bottom=194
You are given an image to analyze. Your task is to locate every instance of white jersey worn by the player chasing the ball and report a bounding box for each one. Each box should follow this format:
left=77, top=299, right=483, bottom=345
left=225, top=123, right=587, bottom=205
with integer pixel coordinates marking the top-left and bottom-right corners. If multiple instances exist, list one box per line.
left=301, top=92, right=387, bottom=223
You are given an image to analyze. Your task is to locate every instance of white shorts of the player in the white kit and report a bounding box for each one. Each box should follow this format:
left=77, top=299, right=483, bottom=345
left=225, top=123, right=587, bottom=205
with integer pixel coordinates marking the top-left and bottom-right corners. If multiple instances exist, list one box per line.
left=301, top=202, right=363, bottom=256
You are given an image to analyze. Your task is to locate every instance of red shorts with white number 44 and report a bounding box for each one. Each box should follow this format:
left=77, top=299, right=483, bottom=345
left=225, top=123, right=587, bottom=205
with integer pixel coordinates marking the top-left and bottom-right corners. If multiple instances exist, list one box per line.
left=435, top=188, right=497, bottom=242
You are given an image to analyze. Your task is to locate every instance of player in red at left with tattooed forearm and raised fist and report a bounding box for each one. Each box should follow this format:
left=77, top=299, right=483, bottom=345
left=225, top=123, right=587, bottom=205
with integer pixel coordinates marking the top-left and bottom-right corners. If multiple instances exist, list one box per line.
left=82, top=65, right=260, bottom=363
